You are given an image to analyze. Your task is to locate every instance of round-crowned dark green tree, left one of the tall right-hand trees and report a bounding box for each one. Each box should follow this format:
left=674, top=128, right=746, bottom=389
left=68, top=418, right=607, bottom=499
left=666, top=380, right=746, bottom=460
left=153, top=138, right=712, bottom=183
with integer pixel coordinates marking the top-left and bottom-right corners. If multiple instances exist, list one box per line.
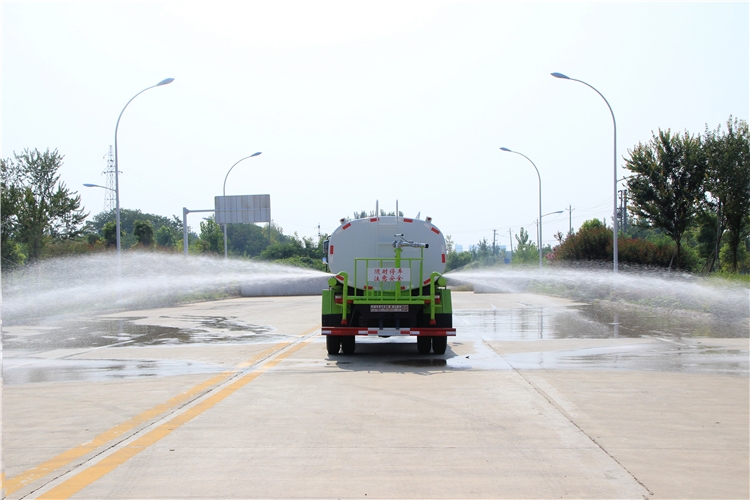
left=626, top=130, right=707, bottom=268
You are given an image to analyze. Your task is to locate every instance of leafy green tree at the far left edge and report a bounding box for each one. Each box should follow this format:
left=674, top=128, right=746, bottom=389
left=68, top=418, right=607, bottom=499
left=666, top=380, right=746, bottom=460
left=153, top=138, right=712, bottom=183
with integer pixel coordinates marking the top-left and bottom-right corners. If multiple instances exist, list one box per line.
left=0, top=149, right=88, bottom=260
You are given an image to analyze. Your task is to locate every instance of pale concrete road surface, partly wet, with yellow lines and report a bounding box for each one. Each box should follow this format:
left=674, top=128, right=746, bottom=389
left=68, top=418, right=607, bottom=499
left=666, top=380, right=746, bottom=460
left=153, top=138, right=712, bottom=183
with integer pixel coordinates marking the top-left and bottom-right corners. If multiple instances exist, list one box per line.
left=3, top=292, right=750, bottom=499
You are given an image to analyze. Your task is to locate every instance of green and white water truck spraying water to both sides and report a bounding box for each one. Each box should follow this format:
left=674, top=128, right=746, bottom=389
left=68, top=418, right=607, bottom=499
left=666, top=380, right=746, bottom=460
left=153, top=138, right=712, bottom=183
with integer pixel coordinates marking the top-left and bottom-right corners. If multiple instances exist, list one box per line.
left=321, top=216, right=456, bottom=355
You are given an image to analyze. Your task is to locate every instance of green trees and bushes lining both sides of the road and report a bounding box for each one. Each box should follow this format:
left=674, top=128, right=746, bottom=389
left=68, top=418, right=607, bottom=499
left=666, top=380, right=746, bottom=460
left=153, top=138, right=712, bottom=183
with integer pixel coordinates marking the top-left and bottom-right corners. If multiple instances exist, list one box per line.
left=0, top=117, right=750, bottom=285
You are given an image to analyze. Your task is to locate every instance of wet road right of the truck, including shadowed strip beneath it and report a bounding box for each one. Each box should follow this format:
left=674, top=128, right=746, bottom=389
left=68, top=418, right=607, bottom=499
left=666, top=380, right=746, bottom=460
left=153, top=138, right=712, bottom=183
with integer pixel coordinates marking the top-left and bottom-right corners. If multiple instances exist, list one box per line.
left=333, top=304, right=750, bottom=375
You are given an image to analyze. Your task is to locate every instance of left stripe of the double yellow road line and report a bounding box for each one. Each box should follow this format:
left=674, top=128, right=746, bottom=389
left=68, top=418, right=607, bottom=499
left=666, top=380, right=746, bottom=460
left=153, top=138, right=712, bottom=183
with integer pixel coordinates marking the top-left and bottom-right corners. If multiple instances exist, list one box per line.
left=2, top=334, right=302, bottom=495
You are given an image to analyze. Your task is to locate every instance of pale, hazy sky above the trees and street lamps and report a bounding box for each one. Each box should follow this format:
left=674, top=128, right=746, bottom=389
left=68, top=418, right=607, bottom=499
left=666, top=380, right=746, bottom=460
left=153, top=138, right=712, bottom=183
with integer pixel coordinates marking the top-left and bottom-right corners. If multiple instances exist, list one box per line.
left=2, top=0, right=750, bottom=249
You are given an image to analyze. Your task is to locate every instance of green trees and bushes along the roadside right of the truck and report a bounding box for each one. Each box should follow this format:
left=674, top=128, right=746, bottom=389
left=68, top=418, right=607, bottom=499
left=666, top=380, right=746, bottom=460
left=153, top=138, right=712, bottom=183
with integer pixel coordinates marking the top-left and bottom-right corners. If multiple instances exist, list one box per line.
left=447, top=117, right=750, bottom=283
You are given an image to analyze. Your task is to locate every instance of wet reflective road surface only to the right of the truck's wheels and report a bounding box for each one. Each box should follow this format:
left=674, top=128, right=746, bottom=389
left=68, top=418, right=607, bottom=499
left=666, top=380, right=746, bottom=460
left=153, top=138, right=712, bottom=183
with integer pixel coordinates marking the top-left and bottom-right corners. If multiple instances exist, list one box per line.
left=456, top=305, right=750, bottom=375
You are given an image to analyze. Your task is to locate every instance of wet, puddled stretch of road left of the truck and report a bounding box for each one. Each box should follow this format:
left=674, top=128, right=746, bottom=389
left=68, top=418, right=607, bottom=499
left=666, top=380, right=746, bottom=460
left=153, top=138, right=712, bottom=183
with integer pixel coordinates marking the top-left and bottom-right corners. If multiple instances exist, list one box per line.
left=3, top=316, right=279, bottom=384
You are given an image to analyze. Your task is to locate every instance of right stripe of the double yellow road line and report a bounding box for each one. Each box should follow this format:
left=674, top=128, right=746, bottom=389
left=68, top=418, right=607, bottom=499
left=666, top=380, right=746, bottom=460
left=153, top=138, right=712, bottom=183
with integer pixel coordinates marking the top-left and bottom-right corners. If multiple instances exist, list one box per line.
left=38, top=338, right=312, bottom=500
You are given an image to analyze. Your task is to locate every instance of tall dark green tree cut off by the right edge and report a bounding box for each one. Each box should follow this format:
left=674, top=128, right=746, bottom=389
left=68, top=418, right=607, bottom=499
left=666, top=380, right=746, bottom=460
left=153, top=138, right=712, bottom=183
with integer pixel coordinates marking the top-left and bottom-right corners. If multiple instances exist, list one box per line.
left=703, top=116, right=750, bottom=272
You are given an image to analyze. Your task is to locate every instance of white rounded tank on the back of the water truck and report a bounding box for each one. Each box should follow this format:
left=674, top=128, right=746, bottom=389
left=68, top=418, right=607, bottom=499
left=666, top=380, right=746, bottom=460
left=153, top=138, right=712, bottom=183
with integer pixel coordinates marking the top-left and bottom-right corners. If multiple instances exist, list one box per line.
left=327, top=216, right=445, bottom=289
